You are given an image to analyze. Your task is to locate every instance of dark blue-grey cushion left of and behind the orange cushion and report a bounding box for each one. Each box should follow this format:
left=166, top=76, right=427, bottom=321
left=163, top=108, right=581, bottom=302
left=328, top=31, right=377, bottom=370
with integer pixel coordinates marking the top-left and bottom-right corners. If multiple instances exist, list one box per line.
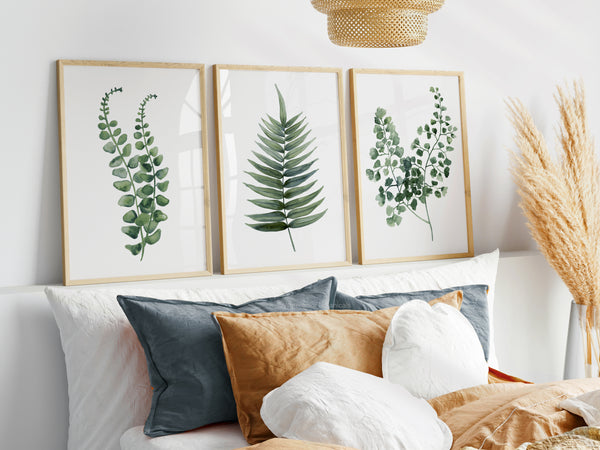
left=117, top=277, right=337, bottom=437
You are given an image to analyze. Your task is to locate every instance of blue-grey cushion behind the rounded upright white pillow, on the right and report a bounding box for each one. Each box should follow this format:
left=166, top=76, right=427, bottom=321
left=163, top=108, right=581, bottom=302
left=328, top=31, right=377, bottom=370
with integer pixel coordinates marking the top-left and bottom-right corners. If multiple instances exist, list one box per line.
left=330, top=284, right=490, bottom=361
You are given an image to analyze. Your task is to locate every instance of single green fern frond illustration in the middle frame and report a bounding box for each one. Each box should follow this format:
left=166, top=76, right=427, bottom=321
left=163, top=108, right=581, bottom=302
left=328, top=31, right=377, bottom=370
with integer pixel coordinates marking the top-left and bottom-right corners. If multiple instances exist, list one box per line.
left=244, top=85, right=327, bottom=252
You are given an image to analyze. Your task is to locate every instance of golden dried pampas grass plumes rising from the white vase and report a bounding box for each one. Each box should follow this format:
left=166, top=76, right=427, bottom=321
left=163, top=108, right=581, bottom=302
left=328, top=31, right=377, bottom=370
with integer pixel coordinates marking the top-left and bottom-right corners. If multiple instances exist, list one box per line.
left=507, top=82, right=600, bottom=305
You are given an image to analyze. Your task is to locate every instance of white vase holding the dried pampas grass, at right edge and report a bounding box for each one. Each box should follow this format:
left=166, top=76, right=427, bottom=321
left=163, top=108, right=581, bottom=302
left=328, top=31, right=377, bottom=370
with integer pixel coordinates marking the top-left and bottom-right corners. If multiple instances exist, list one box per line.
left=563, top=301, right=600, bottom=380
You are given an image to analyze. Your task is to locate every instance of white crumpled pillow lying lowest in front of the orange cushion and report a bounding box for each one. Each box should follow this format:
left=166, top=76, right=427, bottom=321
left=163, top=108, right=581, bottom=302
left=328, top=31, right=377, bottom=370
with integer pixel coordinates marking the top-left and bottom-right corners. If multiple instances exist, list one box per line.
left=260, top=362, right=452, bottom=450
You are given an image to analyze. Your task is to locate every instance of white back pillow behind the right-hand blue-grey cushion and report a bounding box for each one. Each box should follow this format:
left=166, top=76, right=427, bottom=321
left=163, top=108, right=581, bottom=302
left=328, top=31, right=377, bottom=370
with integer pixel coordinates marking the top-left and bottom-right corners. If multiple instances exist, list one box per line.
left=338, top=250, right=499, bottom=368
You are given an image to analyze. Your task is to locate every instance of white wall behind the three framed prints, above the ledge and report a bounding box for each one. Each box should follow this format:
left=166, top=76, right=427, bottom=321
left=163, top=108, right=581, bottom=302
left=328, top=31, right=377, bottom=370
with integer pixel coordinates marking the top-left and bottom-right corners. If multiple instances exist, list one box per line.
left=0, top=0, right=600, bottom=286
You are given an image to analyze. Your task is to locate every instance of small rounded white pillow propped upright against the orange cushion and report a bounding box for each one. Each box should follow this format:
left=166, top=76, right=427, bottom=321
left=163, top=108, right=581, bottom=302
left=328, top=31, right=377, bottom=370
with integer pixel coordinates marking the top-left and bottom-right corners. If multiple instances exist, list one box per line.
left=382, top=300, right=488, bottom=399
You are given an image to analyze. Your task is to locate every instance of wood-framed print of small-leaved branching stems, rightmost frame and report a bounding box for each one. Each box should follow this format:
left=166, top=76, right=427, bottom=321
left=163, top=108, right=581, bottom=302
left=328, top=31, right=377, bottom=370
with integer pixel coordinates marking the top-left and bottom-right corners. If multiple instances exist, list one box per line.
left=350, top=69, right=474, bottom=264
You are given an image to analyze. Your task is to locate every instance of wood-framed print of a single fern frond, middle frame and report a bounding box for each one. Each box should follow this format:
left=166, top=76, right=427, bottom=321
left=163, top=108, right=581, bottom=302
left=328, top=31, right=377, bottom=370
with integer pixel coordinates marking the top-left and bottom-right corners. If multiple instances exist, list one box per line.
left=213, top=65, right=352, bottom=274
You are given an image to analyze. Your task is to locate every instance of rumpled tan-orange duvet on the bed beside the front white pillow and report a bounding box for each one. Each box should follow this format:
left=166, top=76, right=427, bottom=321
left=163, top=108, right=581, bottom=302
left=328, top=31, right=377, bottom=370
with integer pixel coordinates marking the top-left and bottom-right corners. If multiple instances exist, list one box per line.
left=237, top=375, right=600, bottom=450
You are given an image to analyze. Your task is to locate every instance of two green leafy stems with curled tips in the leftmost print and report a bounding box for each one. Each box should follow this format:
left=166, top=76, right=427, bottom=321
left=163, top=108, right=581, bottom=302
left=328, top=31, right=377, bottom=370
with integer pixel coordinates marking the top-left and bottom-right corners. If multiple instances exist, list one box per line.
left=98, top=87, right=169, bottom=261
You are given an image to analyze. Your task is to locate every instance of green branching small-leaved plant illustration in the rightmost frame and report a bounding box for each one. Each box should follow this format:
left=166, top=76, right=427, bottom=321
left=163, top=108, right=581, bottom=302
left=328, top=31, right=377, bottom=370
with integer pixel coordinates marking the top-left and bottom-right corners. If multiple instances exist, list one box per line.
left=366, top=87, right=458, bottom=241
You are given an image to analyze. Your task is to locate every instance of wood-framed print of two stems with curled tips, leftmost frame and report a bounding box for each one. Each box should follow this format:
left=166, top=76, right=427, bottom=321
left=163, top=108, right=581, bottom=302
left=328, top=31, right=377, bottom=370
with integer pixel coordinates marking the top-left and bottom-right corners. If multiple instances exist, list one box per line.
left=57, top=60, right=212, bottom=285
